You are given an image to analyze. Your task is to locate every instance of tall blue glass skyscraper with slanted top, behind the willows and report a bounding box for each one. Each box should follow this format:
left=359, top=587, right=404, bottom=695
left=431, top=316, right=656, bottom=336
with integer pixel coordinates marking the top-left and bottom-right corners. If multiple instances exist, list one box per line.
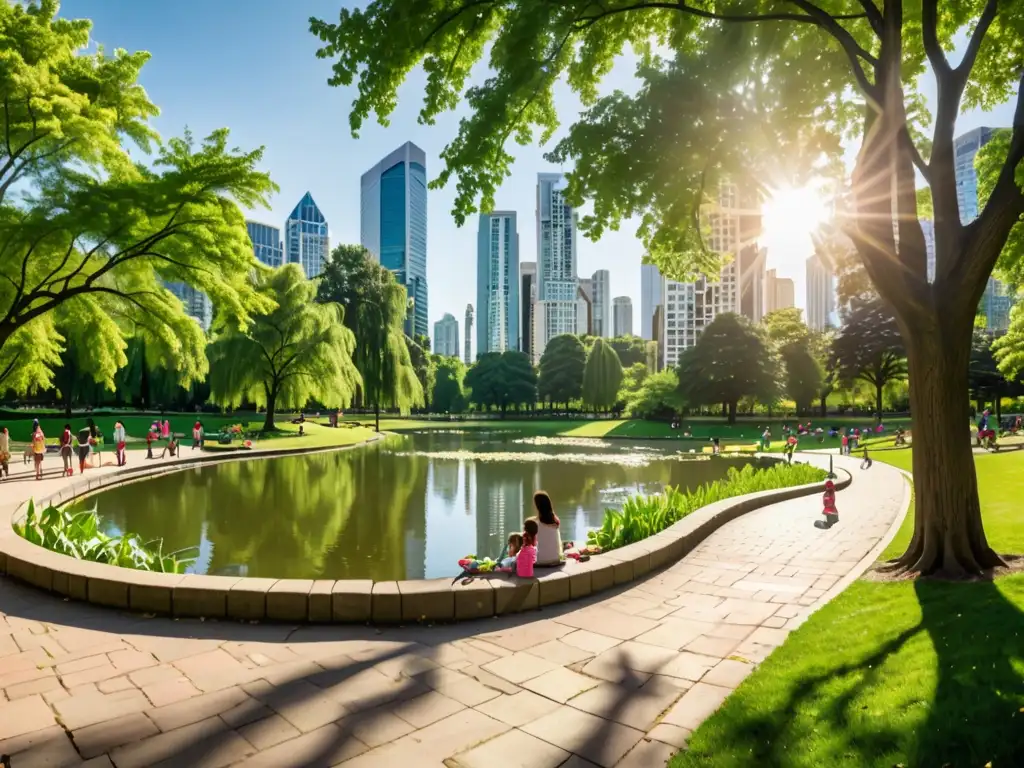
left=359, top=141, right=428, bottom=336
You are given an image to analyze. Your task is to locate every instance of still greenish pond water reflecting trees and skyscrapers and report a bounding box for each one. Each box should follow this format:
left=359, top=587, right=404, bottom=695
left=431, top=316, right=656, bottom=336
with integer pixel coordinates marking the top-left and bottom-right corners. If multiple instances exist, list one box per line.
left=82, top=431, right=770, bottom=581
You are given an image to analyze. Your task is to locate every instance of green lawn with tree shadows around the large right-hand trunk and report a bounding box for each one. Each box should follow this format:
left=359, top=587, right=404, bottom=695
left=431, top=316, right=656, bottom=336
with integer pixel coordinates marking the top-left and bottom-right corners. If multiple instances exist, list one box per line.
left=672, top=451, right=1024, bottom=768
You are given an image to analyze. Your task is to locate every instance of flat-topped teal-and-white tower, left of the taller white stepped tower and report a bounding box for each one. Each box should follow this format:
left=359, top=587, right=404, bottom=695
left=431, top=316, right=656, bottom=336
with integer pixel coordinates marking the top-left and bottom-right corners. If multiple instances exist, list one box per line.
left=476, top=211, right=519, bottom=354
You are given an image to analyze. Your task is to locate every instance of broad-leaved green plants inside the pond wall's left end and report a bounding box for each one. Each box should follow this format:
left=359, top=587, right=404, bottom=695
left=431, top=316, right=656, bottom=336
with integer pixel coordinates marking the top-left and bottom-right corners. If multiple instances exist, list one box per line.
left=14, top=501, right=196, bottom=573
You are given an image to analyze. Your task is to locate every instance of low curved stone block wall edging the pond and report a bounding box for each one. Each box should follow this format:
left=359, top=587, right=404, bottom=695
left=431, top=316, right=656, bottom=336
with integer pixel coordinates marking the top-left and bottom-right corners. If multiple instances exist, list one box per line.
left=0, top=452, right=853, bottom=624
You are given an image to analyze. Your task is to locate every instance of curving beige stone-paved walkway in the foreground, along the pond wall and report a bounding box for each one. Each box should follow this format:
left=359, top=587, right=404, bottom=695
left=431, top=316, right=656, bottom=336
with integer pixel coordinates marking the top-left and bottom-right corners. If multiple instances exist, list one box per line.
left=0, top=457, right=908, bottom=768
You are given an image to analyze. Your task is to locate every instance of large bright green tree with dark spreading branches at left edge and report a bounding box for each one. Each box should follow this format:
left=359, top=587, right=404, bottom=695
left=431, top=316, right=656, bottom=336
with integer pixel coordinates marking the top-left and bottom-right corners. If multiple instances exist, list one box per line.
left=0, top=0, right=275, bottom=390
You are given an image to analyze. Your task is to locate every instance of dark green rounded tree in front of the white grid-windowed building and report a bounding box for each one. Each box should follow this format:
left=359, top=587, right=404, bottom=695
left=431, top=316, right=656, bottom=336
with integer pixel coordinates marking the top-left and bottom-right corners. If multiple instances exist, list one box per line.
left=679, top=312, right=777, bottom=424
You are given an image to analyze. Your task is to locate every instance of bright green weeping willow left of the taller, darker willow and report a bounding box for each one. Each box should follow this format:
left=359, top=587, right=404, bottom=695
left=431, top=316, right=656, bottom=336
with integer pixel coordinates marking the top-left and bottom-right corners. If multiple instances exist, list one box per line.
left=210, top=264, right=359, bottom=431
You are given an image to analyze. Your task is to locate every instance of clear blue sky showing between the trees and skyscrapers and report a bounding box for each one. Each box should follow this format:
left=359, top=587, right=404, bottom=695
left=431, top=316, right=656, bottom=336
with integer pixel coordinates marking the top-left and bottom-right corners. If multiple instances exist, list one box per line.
left=61, top=0, right=1012, bottom=330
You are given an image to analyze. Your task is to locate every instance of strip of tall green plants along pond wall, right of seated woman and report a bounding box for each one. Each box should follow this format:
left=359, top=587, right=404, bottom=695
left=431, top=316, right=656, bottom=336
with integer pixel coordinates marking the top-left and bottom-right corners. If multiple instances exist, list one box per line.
left=587, top=464, right=827, bottom=551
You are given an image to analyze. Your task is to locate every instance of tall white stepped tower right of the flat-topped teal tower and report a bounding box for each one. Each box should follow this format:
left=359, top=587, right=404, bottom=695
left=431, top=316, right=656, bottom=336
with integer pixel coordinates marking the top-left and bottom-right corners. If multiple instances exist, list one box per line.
left=531, top=173, right=579, bottom=358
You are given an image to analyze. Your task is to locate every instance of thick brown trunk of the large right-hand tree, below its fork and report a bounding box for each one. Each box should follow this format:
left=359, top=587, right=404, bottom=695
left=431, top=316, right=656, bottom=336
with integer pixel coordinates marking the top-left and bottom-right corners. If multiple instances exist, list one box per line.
left=895, top=328, right=1002, bottom=578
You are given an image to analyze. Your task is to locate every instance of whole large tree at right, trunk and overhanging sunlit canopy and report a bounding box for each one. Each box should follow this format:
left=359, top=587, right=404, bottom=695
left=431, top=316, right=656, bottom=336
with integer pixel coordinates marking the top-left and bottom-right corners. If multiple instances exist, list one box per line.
left=310, top=0, right=1024, bottom=573
